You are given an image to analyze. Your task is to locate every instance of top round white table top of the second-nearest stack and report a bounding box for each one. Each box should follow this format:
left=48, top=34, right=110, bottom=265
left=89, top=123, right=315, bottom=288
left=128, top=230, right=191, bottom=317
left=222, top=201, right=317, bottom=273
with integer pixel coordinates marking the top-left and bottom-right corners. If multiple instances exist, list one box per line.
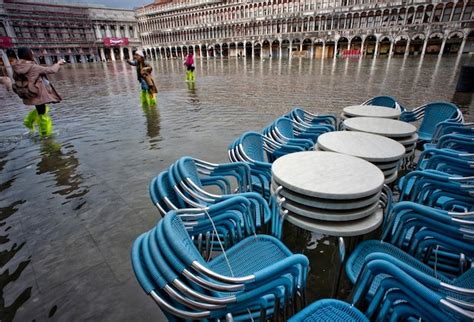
left=317, top=131, right=405, bottom=162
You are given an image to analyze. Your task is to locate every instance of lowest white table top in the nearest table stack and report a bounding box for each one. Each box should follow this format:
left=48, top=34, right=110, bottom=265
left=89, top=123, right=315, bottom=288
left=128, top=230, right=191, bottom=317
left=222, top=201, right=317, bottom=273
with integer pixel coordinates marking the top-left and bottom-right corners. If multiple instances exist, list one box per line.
left=286, top=209, right=383, bottom=237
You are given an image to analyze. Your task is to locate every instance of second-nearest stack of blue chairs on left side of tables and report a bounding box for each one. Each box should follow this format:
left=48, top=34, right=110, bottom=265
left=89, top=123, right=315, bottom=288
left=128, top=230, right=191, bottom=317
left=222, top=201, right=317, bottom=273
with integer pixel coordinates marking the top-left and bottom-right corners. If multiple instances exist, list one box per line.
left=149, top=157, right=277, bottom=233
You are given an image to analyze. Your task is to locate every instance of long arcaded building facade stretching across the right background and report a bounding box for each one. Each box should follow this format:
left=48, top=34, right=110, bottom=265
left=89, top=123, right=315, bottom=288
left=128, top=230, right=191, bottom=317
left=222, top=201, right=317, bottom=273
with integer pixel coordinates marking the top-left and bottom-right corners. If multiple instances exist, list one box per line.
left=136, top=0, right=474, bottom=58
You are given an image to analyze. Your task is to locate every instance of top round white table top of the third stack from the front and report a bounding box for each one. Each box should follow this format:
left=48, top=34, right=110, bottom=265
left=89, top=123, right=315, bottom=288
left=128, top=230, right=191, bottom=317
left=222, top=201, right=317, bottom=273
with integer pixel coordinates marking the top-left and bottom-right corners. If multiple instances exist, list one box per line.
left=343, top=117, right=416, bottom=138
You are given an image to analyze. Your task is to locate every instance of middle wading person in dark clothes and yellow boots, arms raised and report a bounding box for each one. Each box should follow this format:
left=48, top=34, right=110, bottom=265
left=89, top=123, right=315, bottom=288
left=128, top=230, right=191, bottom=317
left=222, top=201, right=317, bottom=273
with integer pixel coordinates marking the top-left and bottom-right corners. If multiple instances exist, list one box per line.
left=127, top=50, right=158, bottom=105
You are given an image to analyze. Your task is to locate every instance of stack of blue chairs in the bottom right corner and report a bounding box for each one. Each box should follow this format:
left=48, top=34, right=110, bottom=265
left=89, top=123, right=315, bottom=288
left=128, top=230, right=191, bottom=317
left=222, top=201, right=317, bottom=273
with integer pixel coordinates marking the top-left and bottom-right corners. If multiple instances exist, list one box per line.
left=352, top=252, right=474, bottom=321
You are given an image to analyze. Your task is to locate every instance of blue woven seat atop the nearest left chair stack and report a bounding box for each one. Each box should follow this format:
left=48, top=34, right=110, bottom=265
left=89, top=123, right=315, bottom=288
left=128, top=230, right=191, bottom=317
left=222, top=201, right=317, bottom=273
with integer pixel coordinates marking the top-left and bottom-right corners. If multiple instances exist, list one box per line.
left=208, top=235, right=291, bottom=277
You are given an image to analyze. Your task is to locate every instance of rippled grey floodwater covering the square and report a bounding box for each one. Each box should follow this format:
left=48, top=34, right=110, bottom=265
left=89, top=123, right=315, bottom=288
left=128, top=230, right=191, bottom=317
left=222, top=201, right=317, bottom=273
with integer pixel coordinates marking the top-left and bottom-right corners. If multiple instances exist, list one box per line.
left=0, top=56, right=473, bottom=321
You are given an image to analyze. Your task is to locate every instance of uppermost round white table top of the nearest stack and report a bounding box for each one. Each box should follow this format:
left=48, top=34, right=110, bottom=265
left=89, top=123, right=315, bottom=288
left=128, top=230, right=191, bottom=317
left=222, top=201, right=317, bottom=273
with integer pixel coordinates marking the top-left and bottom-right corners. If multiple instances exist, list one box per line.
left=272, top=151, right=384, bottom=200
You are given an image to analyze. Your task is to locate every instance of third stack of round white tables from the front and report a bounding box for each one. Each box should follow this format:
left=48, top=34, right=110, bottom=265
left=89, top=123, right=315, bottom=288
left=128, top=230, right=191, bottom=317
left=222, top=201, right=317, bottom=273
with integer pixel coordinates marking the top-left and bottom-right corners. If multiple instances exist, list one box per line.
left=343, top=117, right=418, bottom=157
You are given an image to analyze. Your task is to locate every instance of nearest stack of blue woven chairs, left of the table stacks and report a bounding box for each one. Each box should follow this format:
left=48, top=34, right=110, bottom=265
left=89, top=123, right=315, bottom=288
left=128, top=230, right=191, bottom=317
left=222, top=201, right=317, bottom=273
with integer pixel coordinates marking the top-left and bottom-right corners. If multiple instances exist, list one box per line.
left=132, top=211, right=308, bottom=321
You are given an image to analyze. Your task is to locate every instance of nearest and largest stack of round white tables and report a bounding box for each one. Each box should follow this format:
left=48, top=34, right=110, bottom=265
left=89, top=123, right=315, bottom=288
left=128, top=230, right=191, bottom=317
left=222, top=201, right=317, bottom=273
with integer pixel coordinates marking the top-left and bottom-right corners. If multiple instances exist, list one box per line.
left=272, top=151, right=385, bottom=236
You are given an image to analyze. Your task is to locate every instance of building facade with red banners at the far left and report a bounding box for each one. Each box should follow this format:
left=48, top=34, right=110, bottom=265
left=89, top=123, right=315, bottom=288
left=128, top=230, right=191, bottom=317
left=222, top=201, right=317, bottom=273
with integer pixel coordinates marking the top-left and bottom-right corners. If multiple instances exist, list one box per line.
left=0, top=0, right=140, bottom=64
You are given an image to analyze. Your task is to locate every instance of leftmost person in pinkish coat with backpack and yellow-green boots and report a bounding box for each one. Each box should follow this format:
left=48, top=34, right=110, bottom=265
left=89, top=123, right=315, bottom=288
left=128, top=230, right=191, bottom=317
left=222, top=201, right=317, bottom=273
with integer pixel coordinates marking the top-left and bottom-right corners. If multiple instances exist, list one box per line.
left=12, top=48, right=65, bottom=136
